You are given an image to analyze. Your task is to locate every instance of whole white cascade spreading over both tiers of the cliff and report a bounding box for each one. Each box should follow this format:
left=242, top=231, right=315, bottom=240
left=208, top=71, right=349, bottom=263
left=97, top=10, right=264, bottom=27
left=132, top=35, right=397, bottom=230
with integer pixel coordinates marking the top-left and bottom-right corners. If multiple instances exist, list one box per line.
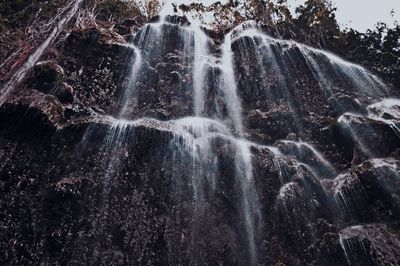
left=76, top=17, right=397, bottom=264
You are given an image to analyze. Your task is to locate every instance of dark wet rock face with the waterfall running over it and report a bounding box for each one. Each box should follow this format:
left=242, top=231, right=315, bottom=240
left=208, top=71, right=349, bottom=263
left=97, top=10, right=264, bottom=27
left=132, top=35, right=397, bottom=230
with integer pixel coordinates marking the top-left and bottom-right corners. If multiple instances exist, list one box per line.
left=0, top=17, right=400, bottom=265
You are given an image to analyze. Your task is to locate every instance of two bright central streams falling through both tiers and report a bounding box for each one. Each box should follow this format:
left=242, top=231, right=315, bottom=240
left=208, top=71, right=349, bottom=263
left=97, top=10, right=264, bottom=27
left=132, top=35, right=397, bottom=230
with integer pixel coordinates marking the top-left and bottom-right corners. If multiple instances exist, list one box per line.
left=167, top=19, right=261, bottom=258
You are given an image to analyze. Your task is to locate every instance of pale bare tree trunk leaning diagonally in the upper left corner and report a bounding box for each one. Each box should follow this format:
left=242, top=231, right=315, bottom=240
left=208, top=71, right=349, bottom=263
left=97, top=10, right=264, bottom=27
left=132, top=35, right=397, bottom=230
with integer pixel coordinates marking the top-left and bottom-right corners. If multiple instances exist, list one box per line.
left=0, top=0, right=83, bottom=106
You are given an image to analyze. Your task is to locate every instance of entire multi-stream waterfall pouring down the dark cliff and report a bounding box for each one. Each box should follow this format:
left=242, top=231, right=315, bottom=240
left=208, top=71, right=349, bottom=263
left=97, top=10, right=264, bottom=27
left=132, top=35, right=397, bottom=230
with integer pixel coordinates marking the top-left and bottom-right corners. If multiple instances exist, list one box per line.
left=72, top=16, right=399, bottom=265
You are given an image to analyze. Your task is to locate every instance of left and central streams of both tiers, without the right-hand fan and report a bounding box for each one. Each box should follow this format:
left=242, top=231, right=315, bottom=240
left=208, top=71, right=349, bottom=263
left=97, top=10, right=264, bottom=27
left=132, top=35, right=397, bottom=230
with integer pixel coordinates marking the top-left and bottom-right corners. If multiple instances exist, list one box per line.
left=76, top=17, right=261, bottom=264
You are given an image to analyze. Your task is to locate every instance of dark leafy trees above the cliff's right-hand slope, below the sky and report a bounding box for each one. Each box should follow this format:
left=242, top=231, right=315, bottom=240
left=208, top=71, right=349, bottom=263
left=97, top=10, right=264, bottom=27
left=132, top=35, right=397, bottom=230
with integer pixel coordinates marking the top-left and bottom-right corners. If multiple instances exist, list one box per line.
left=179, top=0, right=400, bottom=88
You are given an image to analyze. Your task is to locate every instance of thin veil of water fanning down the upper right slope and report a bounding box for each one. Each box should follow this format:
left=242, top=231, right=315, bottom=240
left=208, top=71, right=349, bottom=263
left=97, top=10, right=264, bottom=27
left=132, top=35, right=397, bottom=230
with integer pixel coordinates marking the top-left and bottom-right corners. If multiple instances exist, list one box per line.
left=234, top=26, right=388, bottom=100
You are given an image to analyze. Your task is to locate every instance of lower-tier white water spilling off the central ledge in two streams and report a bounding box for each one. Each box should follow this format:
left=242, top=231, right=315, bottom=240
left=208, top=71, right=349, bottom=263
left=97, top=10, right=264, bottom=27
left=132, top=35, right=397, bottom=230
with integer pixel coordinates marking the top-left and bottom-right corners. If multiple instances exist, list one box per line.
left=174, top=117, right=261, bottom=243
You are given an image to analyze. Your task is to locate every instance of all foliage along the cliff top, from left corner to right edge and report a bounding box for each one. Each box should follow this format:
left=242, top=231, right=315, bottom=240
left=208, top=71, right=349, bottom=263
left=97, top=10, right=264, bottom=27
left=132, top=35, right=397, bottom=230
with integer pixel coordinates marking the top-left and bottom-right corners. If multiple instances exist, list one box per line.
left=0, top=0, right=400, bottom=87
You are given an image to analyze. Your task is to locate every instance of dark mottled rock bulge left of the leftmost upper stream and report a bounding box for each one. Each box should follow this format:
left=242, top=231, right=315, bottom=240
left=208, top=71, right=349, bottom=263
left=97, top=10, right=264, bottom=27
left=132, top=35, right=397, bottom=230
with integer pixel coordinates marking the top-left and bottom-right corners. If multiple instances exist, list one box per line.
left=61, top=28, right=134, bottom=113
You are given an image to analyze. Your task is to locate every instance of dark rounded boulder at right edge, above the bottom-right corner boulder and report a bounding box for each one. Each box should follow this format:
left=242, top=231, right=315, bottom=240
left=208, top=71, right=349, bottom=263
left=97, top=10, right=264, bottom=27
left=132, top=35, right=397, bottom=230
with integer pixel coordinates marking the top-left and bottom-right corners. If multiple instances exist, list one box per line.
left=329, top=158, right=400, bottom=223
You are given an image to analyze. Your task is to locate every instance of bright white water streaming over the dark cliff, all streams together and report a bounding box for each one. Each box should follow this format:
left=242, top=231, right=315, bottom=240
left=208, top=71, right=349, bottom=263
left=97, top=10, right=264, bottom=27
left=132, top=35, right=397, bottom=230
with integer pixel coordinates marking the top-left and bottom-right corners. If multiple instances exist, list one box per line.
left=79, top=18, right=397, bottom=264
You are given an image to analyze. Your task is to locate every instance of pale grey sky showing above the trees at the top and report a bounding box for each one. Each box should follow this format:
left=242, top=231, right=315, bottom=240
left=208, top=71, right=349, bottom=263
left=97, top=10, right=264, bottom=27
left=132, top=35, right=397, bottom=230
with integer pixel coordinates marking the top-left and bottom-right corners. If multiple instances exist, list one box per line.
left=163, top=0, right=400, bottom=32
